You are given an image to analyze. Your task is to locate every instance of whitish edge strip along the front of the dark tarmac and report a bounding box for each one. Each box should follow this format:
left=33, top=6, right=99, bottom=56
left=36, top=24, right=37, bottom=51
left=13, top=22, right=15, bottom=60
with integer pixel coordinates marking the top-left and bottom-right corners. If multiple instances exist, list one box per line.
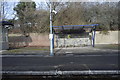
left=0, top=70, right=120, bottom=76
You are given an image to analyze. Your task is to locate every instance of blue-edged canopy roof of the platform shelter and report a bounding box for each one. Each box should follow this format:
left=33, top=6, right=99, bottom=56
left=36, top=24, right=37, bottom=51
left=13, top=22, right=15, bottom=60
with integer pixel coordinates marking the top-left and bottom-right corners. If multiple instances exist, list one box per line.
left=53, top=24, right=98, bottom=34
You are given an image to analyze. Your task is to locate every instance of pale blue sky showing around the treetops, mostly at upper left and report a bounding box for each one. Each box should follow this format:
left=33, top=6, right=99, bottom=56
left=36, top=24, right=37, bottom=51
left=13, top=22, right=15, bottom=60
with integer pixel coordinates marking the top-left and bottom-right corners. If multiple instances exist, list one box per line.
left=0, top=0, right=119, bottom=19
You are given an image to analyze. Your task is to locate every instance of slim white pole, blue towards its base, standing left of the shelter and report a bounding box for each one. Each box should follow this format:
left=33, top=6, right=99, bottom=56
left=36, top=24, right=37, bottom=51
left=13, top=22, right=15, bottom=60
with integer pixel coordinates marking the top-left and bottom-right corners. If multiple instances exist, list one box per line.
left=49, top=2, right=54, bottom=56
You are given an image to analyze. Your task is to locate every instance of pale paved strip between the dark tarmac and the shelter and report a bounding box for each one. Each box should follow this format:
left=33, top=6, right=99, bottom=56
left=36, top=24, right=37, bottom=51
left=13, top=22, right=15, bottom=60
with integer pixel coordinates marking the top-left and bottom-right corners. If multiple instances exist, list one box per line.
left=0, top=47, right=120, bottom=57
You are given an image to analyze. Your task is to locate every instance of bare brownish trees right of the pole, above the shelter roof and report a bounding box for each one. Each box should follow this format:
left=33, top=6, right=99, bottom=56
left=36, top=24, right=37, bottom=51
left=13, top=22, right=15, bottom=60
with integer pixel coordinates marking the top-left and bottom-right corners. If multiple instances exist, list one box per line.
left=53, top=2, right=118, bottom=31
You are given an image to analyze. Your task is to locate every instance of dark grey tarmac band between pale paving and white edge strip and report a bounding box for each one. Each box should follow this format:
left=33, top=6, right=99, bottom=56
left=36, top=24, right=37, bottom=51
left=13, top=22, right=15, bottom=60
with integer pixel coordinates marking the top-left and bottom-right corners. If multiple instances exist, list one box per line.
left=2, top=54, right=119, bottom=71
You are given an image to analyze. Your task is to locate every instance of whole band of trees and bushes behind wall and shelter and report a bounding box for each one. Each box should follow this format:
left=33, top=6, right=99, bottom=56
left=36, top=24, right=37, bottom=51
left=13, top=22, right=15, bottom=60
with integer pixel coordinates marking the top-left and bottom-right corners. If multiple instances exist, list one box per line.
left=7, top=2, right=120, bottom=34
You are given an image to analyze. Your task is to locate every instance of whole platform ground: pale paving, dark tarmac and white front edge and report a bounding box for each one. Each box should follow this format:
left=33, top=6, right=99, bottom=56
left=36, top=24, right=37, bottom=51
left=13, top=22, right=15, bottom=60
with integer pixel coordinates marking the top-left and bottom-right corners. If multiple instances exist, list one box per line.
left=0, top=47, right=120, bottom=80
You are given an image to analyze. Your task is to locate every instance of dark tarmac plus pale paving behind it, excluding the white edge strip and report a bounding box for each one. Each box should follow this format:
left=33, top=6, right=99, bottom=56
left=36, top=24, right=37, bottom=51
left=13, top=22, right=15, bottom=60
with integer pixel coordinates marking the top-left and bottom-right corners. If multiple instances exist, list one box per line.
left=1, top=47, right=120, bottom=71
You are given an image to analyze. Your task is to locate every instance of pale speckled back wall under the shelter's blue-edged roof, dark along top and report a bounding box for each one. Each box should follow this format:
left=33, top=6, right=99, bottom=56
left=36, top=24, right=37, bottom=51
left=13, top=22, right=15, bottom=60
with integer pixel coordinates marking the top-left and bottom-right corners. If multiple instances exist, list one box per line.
left=56, top=33, right=91, bottom=47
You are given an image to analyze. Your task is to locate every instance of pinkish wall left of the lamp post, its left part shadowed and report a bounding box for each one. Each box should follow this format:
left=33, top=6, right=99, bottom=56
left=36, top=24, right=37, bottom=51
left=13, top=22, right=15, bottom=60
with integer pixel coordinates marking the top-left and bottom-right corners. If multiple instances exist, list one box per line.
left=9, top=33, right=50, bottom=48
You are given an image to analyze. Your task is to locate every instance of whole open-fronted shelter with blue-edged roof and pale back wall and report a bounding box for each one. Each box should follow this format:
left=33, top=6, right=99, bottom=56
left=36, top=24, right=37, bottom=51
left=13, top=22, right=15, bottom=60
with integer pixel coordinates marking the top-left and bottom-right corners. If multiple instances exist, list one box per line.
left=53, top=24, right=98, bottom=47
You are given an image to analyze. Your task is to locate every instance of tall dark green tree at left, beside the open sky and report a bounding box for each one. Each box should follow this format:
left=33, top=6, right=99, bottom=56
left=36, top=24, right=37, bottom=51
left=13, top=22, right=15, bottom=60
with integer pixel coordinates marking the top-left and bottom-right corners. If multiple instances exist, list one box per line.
left=14, top=1, right=36, bottom=35
